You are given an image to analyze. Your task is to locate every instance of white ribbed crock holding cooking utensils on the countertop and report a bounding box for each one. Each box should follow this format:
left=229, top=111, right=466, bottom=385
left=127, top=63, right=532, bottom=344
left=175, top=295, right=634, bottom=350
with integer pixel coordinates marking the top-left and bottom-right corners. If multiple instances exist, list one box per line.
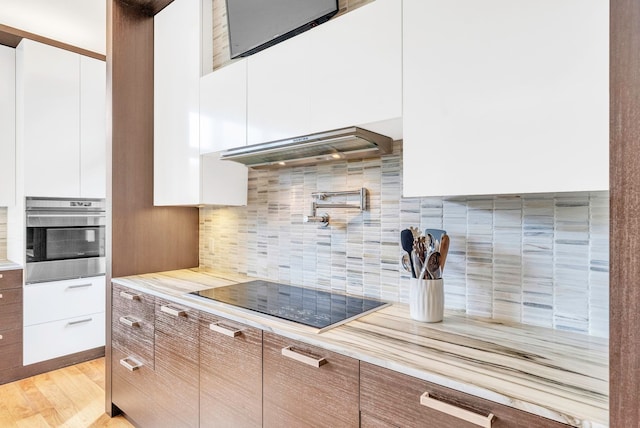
left=409, top=278, right=444, bottom=322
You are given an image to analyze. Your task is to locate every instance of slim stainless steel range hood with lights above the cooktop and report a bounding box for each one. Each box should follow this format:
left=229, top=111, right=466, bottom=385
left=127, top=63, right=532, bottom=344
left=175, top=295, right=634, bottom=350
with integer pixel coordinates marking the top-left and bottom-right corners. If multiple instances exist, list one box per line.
left=220, top=126, right=393, bottom=168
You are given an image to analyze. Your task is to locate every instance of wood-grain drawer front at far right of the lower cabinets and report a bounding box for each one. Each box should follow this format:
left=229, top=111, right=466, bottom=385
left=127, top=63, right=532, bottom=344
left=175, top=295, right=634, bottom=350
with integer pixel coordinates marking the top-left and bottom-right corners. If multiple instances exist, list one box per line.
left=360, top=362, right=568, bottom=428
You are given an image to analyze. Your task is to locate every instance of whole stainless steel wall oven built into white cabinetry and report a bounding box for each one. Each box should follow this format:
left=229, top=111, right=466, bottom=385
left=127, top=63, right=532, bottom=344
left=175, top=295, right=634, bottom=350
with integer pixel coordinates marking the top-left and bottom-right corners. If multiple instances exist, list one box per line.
left=25, top=197, right=106, bottom=284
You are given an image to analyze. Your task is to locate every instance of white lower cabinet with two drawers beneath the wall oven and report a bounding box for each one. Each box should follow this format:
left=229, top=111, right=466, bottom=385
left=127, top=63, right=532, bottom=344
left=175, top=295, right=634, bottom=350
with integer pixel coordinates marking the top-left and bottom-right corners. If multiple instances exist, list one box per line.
left=23, top=276, right=106, bottom=365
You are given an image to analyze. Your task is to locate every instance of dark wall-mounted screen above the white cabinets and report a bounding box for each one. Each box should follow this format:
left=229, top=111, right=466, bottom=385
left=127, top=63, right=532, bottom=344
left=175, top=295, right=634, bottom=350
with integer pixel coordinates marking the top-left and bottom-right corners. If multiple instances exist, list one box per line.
left=226, top=0, right=338, bottom=58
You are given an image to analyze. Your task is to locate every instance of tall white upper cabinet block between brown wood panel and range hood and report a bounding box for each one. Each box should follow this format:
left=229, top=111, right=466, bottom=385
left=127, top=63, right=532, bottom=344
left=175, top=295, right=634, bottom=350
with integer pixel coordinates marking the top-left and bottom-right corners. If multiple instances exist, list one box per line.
left=153, top=0, right=248, bottom=205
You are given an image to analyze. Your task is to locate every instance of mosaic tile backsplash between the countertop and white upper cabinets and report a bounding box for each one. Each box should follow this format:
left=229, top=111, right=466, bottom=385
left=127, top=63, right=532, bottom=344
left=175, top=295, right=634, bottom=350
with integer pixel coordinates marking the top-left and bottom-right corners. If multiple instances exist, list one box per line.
left=200, top=142, right=609, bottom=337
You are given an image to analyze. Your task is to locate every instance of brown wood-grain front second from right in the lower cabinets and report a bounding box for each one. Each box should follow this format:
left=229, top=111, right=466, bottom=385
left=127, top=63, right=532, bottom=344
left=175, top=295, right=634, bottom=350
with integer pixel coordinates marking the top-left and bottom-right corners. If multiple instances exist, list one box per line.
left=263, top=332, right=359, bottom=427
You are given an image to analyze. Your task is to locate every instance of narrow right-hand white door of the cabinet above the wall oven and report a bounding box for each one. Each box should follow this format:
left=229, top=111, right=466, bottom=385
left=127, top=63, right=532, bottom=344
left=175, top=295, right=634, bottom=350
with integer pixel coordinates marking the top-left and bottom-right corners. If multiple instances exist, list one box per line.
left=80, top=56, right=107, bottom=198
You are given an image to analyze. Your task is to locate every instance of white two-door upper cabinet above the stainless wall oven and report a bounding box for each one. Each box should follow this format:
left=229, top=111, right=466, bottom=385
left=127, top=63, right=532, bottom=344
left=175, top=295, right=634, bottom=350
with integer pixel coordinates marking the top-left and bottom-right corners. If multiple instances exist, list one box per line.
left=16, top=39, right=106, bottom=198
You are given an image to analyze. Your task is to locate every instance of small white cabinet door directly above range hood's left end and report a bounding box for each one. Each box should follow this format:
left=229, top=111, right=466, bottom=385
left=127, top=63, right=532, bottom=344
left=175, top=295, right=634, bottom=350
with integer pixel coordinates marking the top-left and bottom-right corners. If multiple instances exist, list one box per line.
left=200, top=59, right=247, bottom=154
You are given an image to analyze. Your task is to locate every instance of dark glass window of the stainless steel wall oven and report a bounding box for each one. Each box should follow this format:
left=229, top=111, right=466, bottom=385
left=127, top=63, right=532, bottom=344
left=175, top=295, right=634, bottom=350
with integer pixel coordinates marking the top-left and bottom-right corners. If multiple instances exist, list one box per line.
left=27, top=226, right=105, bottom=262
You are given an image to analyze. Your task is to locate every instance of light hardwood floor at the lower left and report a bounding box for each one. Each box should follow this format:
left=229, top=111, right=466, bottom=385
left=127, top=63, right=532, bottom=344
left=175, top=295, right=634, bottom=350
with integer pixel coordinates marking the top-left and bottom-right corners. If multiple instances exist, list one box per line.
left=0, top=358, right=133, bottom=428
